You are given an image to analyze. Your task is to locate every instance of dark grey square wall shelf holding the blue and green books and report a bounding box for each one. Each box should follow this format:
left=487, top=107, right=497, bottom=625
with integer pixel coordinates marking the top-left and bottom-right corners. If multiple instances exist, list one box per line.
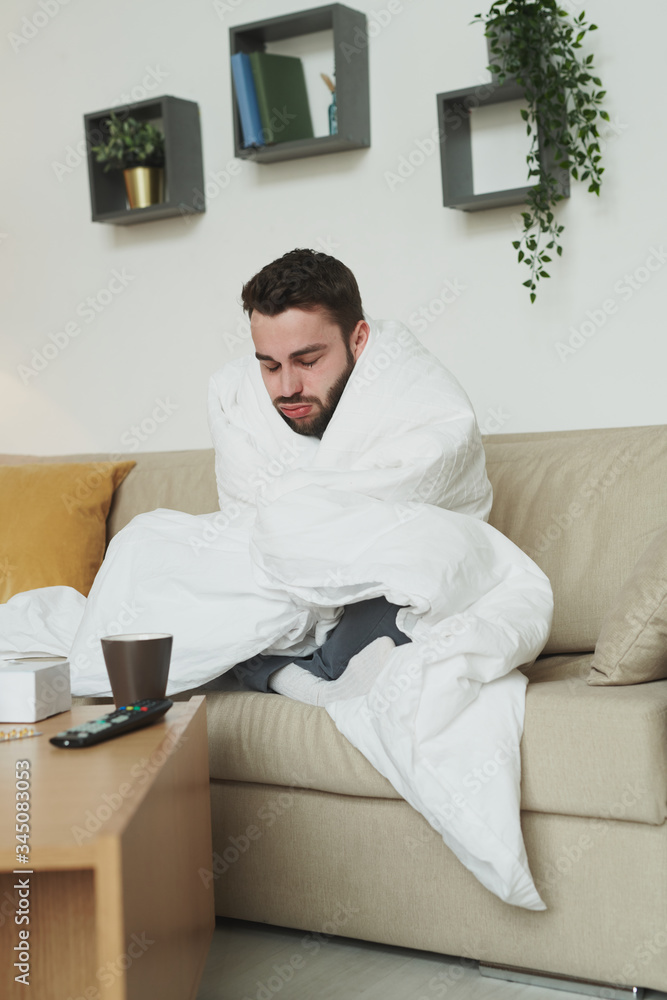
left=229, top=3, right=371, bottom=163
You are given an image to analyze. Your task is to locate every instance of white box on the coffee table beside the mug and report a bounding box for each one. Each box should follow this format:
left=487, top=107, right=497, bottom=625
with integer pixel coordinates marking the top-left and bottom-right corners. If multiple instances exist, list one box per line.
left=0, top=657, right=72, bottom=722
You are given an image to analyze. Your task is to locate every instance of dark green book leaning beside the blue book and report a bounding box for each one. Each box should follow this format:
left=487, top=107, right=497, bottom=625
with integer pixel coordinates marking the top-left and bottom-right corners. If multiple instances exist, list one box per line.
left=250, top=52, right=313, bottom=143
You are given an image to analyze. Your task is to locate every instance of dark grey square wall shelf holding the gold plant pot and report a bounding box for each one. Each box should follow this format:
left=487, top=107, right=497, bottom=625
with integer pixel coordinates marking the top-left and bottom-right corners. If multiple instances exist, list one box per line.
left=83, top=96, right=206, bottom=226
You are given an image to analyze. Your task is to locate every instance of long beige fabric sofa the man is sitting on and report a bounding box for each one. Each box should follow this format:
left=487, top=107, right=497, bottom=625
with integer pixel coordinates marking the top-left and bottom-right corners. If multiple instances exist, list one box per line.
left=6, top=427, right=667, bottom=996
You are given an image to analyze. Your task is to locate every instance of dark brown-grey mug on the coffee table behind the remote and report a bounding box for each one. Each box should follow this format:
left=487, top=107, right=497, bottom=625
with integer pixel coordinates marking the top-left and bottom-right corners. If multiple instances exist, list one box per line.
left=101, top=632, right=174, bottom=708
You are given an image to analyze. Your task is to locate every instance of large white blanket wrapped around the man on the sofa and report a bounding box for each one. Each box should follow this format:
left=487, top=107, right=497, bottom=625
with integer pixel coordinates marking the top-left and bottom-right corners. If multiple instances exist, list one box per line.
left=0, top=323, right=552, bottom=910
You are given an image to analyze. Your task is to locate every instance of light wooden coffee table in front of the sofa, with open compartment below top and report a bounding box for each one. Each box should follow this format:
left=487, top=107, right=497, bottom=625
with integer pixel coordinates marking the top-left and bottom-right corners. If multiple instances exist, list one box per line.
left=0, top=697, right=215, bottom=1000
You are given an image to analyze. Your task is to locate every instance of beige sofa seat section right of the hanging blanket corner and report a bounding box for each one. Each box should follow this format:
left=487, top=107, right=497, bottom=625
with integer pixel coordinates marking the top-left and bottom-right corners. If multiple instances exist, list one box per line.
left=521, top=655, right=667, bottom=830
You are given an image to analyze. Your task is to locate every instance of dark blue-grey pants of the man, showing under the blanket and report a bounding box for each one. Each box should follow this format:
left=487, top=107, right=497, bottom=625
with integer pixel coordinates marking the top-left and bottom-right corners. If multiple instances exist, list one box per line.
left=233, top=597, right=411, bottom=691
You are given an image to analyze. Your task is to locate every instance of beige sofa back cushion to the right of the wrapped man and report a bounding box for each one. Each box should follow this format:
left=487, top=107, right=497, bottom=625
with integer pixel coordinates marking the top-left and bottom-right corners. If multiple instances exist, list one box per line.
left=484, top=426, right=667, bottom=653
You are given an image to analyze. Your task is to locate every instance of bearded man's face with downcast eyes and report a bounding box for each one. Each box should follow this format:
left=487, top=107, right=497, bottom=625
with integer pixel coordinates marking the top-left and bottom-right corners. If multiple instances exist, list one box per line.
left=250, top=307, right=369, bottom=438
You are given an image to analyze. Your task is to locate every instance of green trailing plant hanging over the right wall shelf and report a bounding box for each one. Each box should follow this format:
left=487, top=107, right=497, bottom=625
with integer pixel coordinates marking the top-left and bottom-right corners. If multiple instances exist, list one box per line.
left=474, top=0, right=609, bottom=302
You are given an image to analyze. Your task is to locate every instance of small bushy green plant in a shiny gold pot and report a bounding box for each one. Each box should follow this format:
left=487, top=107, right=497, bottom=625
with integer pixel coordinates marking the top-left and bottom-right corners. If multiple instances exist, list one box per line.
left=91, top=111, right=164, bottom=208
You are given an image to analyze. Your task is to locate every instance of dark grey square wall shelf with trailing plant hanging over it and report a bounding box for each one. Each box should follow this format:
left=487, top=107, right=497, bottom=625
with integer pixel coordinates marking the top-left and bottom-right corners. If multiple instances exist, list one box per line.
left=437, top=81, right=570, bottom=212
